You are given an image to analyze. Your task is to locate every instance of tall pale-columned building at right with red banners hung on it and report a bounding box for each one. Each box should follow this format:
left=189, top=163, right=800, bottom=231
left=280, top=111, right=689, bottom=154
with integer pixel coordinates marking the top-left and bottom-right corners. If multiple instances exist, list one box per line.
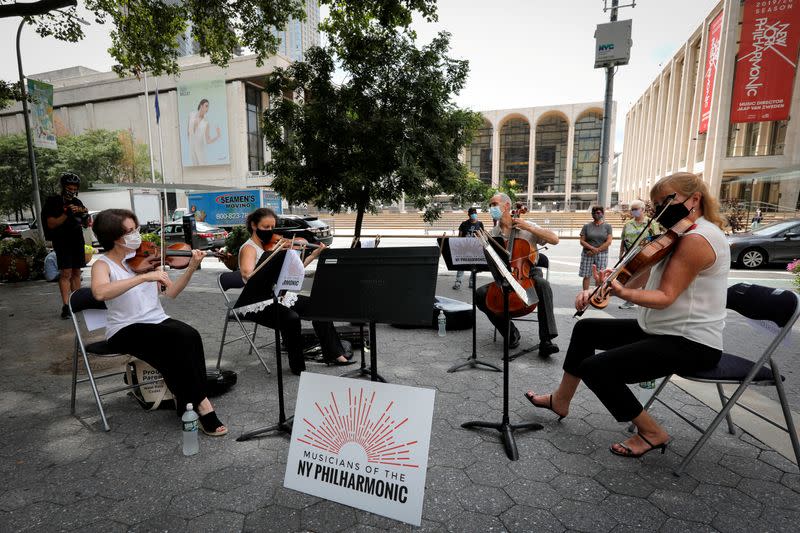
left=618, top=0, right=800, bottom=210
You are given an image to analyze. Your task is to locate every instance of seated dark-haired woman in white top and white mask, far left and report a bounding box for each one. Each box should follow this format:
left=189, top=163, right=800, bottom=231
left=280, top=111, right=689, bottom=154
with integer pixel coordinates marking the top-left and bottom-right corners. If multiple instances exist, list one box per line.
left=92, top=209, right=228, bottom=436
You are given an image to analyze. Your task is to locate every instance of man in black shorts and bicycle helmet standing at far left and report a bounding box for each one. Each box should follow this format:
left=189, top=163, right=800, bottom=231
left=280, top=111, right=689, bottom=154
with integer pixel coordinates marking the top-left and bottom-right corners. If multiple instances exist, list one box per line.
left=42, top=172, right=89, bottom=318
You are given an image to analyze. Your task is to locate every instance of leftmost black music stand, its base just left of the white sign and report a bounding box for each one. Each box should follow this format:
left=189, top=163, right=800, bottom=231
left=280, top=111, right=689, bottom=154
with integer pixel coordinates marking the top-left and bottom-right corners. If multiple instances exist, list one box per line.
left=235, top=250, right=294, bottom=442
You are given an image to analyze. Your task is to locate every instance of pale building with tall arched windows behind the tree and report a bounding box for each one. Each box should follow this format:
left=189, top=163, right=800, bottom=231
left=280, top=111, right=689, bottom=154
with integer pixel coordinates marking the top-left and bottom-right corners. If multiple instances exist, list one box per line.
left=465, top=102, right=616, bottom=210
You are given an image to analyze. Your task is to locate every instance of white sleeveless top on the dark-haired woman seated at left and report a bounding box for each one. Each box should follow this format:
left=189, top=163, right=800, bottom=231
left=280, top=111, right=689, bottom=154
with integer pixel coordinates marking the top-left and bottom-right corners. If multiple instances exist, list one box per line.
left=98, top=255, right=169, bottom=339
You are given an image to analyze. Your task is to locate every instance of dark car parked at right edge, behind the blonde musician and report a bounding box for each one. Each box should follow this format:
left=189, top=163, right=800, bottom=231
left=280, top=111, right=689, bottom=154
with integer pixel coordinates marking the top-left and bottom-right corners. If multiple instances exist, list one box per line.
left=728, top=218, right=800, bottom=269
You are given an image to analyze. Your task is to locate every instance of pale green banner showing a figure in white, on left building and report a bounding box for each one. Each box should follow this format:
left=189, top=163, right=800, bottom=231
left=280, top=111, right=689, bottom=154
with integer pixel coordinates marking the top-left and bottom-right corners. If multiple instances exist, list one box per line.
left=178, top=79, right=230, bottom=167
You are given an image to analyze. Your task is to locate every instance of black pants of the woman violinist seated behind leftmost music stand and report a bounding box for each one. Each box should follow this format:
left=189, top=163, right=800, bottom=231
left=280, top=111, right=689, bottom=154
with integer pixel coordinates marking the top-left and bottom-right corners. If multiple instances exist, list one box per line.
left=247, top=295, right=345, bottom=375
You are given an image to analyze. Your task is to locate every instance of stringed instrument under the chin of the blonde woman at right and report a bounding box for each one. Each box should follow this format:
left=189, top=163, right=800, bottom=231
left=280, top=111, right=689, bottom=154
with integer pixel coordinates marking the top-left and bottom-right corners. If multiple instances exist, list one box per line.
left=575, top=214, right=694, bottom=316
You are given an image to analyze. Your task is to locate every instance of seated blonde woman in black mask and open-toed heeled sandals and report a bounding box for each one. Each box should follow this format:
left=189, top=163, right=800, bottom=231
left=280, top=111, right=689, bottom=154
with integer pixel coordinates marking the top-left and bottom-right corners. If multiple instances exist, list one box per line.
left=525, top=172, right=730, bottom=457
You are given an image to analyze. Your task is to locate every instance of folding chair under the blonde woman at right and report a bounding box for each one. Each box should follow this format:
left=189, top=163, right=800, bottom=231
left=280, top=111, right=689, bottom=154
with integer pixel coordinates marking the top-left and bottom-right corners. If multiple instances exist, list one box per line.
left=644, top=283, right=800, bottom=475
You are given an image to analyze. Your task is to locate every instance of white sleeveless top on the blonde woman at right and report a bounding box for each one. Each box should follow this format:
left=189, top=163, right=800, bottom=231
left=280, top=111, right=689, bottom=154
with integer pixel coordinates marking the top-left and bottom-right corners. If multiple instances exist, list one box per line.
left=637, top=217, right=731, bottom=350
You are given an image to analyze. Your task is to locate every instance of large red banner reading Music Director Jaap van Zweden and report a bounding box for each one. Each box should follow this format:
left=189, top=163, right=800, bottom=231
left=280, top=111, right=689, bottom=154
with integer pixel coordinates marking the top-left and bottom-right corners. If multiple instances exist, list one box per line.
left=731, top=0, right=800, bottom=122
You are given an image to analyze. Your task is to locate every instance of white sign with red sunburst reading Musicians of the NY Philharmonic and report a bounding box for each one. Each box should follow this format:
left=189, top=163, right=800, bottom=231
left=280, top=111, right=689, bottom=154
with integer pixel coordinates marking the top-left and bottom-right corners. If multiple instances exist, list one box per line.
left=283, top=372, right=434, bottom=526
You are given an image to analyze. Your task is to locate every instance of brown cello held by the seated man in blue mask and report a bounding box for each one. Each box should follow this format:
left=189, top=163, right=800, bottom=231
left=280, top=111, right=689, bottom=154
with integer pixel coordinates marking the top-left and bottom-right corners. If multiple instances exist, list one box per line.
left=486, top=204, right=537, bottom=317
